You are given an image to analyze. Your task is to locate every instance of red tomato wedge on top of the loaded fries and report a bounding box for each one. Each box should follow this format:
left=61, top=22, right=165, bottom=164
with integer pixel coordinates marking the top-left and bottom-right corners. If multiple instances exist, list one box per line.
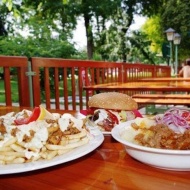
left=14, top=107, right=40, bottom=125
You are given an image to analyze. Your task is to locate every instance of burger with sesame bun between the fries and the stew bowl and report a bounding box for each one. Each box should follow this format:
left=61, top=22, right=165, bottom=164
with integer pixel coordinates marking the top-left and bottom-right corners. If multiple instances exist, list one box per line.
left=87, top=92, right=142, bottom=131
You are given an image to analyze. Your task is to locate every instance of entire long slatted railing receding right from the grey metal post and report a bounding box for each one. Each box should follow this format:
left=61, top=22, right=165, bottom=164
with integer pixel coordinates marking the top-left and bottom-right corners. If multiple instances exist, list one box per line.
left=0, top=56, right=171, bottom=110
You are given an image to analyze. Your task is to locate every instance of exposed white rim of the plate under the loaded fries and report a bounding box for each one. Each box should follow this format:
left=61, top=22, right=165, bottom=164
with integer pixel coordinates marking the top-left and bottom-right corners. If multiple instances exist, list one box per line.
left=0, top=128, right=104, bottom=174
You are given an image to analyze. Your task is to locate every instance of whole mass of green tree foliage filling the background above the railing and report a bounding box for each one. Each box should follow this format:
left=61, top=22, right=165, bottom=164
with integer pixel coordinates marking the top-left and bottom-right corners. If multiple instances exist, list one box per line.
left=0, top=0, right=190, bottom=64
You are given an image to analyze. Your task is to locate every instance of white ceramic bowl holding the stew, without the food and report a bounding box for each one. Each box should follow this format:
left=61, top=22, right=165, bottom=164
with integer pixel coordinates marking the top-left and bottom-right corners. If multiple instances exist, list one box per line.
left=111, top=120, right=190, bottom=171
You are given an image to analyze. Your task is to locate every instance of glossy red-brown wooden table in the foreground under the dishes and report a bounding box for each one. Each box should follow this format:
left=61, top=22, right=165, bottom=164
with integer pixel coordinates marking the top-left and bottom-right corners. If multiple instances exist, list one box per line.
left=0, top=108, right=190, bottom=190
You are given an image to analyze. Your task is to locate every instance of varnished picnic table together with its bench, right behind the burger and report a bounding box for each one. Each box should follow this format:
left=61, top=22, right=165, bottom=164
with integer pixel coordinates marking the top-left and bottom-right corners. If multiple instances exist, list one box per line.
left=84, top=80, right=190, bottom=113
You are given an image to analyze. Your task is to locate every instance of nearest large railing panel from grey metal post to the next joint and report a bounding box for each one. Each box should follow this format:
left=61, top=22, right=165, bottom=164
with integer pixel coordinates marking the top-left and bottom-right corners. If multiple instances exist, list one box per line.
left=31, top=57, right=122, bottom=110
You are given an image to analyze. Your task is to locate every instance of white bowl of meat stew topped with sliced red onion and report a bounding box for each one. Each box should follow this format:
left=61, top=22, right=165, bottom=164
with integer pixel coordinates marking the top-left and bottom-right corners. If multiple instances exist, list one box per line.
left=111, top=108, right=190, bottom=171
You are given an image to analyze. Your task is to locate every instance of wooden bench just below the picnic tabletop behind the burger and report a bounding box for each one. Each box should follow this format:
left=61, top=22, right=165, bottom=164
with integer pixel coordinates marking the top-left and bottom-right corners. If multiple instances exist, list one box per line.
left=132, top=94, right=190, bottom=114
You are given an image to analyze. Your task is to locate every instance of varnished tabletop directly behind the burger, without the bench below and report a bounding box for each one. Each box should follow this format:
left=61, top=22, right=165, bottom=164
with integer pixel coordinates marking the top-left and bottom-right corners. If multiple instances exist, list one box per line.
left=83, top=81, right=190, bottom=92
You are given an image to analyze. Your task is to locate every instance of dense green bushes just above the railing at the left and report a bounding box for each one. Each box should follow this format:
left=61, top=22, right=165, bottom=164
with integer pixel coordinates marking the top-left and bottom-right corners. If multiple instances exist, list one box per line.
left=0, top=36, right=77, bottom=58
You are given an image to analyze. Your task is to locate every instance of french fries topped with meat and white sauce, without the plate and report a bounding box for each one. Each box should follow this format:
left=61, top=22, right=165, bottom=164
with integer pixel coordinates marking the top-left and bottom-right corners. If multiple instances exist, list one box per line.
left=0, top=106, right=92, bottom=165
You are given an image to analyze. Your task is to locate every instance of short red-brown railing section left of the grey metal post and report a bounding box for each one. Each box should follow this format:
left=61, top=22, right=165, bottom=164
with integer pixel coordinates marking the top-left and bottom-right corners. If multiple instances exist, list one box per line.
left=0, top=56, right=30, bottom=106
